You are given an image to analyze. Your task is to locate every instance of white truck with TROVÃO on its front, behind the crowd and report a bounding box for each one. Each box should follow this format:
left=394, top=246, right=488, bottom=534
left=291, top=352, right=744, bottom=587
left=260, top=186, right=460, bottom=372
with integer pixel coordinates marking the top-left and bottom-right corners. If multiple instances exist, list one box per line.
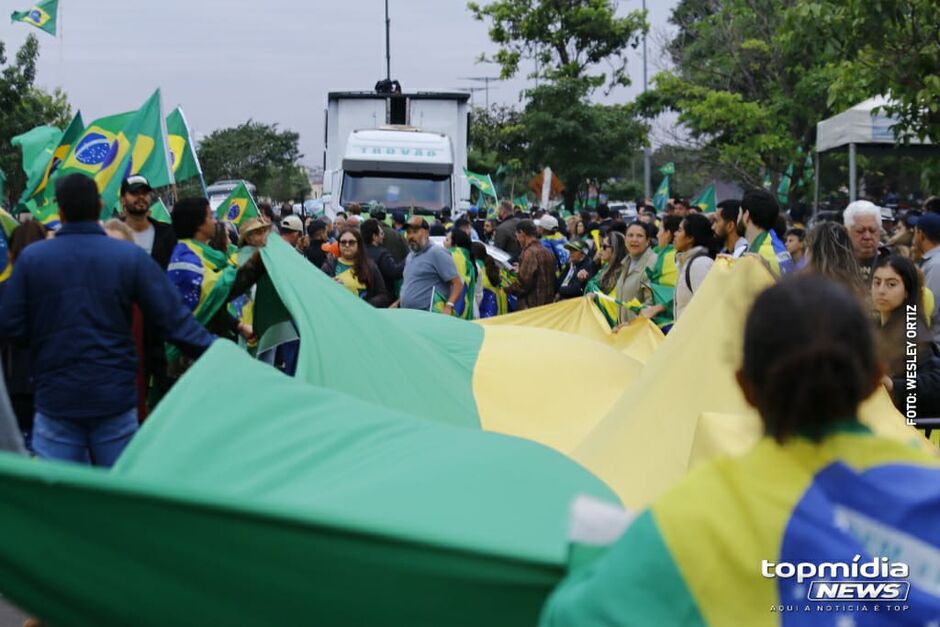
left=323, top=91, right=470, bottom=217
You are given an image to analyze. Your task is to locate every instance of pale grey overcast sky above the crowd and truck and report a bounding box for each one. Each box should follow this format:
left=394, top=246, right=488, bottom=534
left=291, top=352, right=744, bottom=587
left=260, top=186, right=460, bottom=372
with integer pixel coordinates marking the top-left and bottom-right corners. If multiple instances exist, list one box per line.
left=0, top=0, right=677, bottom=165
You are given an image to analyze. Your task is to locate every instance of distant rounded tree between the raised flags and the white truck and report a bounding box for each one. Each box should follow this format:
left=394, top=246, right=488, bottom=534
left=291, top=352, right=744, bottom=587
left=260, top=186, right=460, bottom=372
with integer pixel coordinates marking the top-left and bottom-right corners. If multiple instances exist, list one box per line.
left=196, top=120, right=303, bottom=196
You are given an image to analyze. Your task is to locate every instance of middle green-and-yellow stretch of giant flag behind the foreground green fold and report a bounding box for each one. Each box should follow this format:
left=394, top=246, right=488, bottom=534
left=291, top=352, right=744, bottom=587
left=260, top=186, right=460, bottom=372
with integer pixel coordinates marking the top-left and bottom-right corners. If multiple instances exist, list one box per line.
left=255, top=238, right=641, bottom=452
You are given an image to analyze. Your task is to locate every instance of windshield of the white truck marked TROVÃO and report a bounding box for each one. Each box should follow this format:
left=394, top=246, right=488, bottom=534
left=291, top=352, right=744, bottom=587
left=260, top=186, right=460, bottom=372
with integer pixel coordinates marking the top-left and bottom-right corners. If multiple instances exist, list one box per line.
left=340, top=172, right=453, bottom=211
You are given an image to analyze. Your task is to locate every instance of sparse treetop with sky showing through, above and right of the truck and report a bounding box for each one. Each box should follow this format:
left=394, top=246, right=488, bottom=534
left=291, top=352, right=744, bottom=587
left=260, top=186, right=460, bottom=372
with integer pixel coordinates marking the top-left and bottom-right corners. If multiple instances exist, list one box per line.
left=467, top=0, right=646, bottom=87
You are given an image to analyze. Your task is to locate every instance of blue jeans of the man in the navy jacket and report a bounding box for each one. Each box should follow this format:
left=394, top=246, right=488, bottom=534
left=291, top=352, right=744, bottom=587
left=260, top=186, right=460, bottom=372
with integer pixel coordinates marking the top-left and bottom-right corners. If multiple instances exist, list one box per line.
left=33, top=407, right=137, bottom=467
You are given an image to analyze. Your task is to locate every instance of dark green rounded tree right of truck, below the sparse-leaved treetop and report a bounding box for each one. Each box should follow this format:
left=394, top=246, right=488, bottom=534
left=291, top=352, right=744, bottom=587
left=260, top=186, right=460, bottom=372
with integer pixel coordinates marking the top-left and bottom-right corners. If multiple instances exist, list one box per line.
left=523, top=79, right=646, bottom=207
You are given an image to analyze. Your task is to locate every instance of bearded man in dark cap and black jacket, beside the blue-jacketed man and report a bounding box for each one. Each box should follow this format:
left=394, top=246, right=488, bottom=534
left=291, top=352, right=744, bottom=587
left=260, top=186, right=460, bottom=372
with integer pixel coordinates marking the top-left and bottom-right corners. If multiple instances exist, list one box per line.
left=121, top=175, right=176, bottom=412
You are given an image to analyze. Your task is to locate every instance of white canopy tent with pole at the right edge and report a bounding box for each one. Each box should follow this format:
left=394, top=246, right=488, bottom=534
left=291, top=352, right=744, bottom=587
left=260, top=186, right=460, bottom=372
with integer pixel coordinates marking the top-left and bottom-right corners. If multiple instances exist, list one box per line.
left=815, top=96, right=930, bottom=205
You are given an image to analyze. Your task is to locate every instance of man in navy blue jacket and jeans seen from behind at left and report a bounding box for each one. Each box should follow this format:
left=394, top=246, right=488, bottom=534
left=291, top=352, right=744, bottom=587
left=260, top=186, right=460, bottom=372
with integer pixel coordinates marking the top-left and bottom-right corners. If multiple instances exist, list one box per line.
left=0, top=174, right=213, bottom=466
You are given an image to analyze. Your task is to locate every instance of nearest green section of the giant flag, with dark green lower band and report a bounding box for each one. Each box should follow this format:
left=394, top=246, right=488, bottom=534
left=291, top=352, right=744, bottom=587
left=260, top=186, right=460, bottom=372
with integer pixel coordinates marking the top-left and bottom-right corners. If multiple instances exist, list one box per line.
left=0, top=338, right=614, bottom=627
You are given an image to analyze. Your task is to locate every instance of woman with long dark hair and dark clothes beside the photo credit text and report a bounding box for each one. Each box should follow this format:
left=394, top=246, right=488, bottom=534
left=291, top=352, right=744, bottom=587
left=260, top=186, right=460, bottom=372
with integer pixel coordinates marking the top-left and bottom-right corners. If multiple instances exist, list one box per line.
left=871, top=255, right=940, bottom=418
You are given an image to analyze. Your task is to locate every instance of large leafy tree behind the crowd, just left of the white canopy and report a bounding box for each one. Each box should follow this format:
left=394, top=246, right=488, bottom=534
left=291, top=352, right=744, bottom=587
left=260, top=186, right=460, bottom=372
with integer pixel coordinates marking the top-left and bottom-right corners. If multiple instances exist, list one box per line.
left=640, top=0, right=836, bottom=202
